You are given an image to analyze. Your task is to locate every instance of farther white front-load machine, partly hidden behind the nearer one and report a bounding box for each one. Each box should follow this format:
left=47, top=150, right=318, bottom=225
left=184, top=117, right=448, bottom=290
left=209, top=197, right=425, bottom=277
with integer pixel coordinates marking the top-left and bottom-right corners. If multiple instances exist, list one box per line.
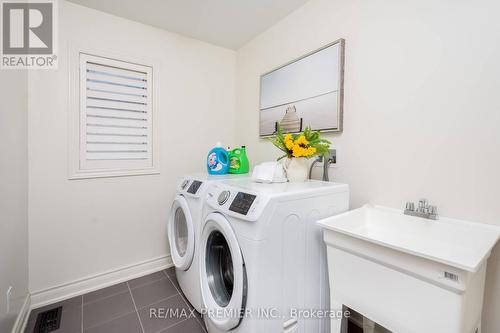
left=167, top=173, right=246, bottom=312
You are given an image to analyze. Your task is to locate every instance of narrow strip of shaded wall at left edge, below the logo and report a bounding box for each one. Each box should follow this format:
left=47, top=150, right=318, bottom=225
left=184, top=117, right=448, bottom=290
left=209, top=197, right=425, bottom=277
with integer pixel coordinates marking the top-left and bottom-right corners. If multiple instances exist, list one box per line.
left=0, top=70, right=28, bottom=332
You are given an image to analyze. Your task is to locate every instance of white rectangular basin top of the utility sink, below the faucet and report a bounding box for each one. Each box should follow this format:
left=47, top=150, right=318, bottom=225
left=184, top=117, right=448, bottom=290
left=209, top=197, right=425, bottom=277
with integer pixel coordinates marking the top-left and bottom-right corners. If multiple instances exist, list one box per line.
left=319, top=205, right=500, bottom=272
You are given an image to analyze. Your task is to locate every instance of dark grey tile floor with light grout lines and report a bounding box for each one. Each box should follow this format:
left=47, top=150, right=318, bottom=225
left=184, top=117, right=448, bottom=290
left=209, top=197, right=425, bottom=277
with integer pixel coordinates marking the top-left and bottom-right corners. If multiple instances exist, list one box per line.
left=24, top=268, right=206, bottom=333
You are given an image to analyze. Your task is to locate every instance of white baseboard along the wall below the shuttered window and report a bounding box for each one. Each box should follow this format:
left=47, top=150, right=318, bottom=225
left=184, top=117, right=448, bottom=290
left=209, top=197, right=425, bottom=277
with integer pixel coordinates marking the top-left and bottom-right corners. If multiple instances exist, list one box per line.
left=31, top=255, right=173, bottom=309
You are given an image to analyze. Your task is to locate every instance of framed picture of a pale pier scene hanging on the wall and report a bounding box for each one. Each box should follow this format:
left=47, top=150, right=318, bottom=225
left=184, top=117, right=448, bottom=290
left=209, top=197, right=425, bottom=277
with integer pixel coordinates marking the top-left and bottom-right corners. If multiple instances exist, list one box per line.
left=259, top=39, right=345, bottom=137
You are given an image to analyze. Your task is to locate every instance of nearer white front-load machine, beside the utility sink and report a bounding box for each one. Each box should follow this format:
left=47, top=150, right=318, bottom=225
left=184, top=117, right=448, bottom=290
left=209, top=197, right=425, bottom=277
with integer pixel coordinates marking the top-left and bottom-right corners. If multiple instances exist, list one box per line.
left=199, top=179, right=349, bottom=333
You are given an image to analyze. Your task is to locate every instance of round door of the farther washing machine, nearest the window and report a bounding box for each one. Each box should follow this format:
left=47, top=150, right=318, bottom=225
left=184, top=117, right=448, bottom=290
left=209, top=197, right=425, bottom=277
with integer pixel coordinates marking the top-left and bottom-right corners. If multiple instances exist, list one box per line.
left=167, top=195, right=194, bottom=270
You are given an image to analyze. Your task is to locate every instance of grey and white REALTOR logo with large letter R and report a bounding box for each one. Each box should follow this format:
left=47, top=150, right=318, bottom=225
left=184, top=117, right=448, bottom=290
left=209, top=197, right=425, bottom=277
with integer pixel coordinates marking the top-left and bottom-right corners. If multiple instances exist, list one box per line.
left=0, top=0, right=57, bottom=69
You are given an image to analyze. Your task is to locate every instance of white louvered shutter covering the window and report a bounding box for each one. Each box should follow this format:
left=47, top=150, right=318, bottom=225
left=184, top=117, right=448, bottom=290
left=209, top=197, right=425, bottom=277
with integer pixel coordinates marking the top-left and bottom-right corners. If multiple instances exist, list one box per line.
left=79, top=53, right=154, bottom=176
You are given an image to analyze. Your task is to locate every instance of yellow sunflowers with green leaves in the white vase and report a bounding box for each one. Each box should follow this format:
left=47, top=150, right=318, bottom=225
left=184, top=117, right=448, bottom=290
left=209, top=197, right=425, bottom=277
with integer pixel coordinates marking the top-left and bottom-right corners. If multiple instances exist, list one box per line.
left=269, top=126, right=331, bottom=161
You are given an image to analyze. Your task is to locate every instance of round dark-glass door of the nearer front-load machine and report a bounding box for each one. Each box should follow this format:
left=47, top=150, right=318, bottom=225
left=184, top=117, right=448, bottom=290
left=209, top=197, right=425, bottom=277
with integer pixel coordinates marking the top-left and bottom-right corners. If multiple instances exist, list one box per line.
left=200, top=213, right=247, bottom=331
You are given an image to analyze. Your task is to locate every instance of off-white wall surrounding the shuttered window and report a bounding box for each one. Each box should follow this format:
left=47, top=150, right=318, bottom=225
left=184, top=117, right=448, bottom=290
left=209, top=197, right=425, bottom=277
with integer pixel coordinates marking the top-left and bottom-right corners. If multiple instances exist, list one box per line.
left=29, top=1, right=235, bottom=293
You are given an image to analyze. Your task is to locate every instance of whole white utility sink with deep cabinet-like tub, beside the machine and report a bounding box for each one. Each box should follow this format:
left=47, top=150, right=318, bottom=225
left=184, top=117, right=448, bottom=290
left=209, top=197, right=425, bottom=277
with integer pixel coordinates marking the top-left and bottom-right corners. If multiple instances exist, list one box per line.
left=318, top=205, right=500, bottom=333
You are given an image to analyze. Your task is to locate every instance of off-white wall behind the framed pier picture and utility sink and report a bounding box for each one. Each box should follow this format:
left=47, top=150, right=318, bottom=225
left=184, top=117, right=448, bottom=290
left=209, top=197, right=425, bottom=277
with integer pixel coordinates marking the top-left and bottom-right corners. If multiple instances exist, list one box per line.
left=237, top=0, right=500, bottom=333
